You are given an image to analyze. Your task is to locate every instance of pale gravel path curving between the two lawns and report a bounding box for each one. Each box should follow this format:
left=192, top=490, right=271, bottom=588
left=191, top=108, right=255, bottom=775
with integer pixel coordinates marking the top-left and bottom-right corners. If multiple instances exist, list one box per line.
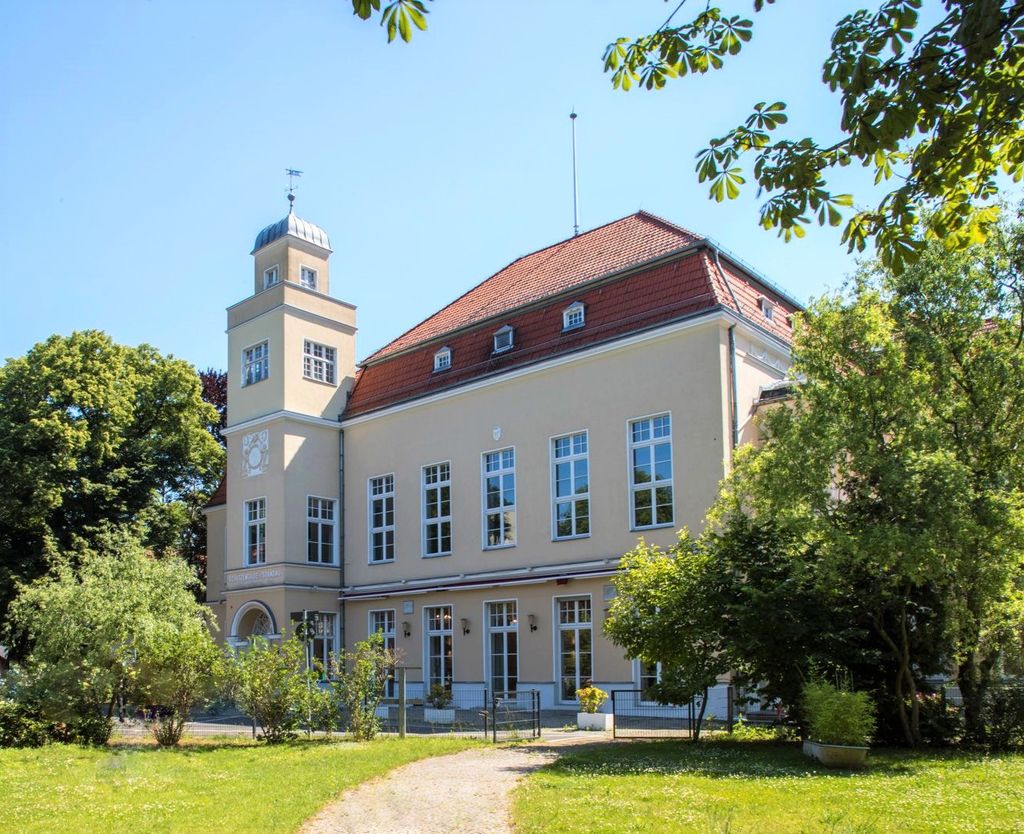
left=300, top=736, right=598, bottom=834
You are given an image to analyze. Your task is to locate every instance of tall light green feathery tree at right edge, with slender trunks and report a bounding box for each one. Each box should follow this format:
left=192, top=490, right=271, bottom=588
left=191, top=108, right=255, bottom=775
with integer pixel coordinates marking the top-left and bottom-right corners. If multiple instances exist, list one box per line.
left=713, top=220, right=1024, bottom=744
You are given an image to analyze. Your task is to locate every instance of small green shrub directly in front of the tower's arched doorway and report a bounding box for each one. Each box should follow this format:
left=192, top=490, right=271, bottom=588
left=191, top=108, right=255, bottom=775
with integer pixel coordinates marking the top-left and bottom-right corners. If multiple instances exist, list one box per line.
left=229, top=637, right=305, bottom=744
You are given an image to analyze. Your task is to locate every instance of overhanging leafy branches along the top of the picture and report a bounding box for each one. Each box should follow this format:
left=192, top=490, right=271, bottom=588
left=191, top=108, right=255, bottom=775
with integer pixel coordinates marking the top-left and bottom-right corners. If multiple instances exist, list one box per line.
left=352, top=0, right=1024, bottom=273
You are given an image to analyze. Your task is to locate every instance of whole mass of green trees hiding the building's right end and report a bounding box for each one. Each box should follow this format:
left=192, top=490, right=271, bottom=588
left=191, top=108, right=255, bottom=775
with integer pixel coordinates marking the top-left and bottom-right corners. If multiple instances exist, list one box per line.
left=608, top=219, right=1024, bottom=745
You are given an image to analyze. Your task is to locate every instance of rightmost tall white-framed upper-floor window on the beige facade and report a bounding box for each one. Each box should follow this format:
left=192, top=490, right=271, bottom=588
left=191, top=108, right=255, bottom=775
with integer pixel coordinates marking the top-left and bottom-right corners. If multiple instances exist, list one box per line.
left=630, top=414, right=675, bottom=530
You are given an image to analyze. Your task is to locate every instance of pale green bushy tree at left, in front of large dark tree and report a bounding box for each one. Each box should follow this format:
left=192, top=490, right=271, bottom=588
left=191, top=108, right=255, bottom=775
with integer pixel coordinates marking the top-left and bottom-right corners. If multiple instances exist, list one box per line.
left=10, top=532, right=216, bottom=741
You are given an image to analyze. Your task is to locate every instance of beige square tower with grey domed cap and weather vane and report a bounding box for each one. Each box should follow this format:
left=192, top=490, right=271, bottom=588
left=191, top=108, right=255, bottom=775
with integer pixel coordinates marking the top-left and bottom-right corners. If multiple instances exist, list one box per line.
left=207, top=202, right=355, bottom=659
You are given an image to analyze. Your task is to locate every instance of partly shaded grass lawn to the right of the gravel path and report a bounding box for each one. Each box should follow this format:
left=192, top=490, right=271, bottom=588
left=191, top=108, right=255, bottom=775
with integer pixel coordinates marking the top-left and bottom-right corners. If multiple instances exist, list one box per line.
left=515, top=741, right=1024, bottom=834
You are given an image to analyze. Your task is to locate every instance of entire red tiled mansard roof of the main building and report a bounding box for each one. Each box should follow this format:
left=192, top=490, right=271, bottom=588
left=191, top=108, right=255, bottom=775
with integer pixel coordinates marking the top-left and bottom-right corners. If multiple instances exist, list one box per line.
left=344, top=212, right=797, bottom=418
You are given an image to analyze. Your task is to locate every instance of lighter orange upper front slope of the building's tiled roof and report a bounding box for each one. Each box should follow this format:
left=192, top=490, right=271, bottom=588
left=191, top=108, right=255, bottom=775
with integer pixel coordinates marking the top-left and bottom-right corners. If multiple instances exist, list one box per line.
left=365, top=211, right=700, bottom=364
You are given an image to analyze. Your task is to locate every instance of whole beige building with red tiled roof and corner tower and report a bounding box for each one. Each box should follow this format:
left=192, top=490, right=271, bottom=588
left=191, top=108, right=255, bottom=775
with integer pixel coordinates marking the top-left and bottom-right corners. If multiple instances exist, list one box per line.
left=207, top=206, right=799, bottom=711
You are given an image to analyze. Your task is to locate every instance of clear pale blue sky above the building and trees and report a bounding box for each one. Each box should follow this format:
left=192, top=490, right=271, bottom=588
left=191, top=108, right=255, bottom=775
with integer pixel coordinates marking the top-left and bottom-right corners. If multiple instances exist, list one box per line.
left=0, top=0, right=913, bottom=367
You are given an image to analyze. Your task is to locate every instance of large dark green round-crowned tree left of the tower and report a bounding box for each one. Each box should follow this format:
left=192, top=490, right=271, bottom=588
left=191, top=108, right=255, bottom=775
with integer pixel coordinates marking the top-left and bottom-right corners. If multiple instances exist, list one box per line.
left=0, top=331, right=223, bottom=635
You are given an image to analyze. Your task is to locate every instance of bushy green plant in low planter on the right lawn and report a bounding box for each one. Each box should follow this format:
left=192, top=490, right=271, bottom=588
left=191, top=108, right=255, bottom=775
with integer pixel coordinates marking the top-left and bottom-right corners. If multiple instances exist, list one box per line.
left=803, top=680, right=874, bottom=767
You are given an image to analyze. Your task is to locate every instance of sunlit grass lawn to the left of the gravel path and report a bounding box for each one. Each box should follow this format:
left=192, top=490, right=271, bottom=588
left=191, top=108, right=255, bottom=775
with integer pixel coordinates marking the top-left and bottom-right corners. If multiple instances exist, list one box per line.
left=0, top=737, right=474, bottom=834
